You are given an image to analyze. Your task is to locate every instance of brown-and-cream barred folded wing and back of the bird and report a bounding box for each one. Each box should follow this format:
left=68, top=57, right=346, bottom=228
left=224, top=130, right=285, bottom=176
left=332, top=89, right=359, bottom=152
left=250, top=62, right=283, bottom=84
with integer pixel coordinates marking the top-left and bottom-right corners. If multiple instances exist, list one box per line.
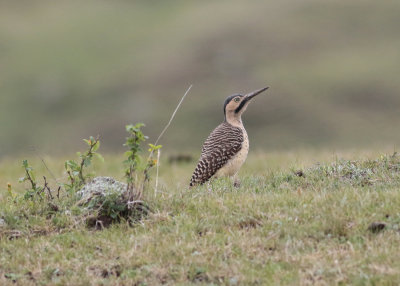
left=190, top=122, right=243, bottom=186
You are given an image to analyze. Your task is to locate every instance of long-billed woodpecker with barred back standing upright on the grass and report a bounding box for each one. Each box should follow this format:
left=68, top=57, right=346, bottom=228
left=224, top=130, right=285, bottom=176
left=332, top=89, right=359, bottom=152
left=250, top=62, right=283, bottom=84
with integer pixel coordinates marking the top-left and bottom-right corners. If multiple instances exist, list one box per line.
left=189, top=87, right=269, bottom=187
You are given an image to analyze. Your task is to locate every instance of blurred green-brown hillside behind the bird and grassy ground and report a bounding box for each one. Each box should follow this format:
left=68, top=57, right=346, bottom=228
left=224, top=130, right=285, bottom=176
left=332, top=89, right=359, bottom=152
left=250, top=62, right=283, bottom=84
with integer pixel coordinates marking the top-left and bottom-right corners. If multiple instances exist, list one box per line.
left=0, top=0, right=400, bottom=157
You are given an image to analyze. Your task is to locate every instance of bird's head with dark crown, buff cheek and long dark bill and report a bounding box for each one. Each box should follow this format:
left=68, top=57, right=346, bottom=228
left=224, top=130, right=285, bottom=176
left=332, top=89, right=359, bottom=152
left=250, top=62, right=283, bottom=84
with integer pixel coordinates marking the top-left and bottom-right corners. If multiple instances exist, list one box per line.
left=224, top=87, right=269, bottom=124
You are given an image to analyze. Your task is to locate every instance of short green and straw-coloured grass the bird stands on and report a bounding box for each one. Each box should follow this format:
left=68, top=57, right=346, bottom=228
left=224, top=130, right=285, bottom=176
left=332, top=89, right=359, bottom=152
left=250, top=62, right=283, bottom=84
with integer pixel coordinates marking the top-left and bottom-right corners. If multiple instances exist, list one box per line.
left=0, top=151, right=400, bottom=285
